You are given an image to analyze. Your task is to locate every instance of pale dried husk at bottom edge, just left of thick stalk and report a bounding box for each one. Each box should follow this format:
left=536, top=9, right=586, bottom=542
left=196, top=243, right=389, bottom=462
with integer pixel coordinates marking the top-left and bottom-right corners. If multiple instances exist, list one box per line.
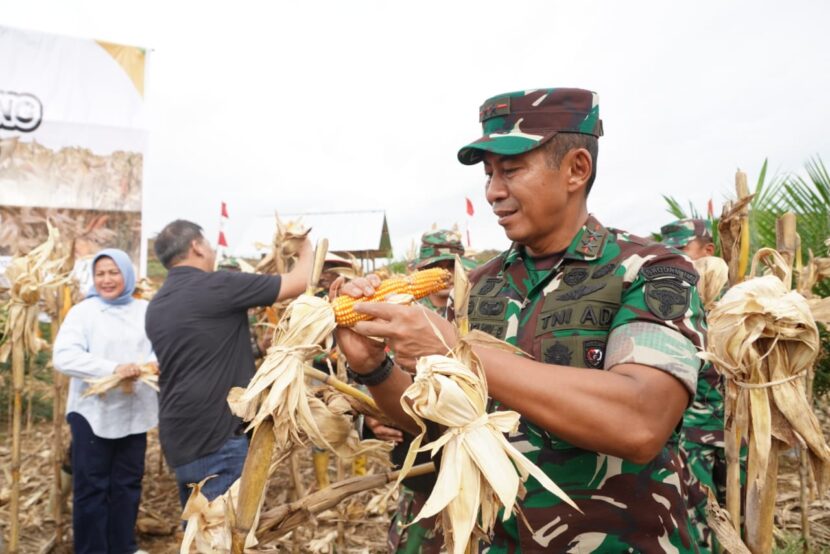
left=179, top=475, right=259, bottom=554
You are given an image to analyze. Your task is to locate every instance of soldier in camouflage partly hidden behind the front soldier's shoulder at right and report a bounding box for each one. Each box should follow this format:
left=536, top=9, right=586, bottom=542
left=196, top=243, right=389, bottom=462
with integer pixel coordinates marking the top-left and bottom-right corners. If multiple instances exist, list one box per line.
left=660, top=219, right=726, bottom=552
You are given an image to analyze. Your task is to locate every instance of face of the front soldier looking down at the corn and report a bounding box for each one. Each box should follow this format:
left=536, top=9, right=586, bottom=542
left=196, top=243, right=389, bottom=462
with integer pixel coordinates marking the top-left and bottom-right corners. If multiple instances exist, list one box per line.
left=484, top=148, right=568, bottom=254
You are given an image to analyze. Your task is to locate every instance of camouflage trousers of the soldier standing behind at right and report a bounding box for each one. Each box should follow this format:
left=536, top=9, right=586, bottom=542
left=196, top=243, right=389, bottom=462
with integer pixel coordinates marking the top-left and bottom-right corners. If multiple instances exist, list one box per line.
left=681, top=441, right=726, bottom=554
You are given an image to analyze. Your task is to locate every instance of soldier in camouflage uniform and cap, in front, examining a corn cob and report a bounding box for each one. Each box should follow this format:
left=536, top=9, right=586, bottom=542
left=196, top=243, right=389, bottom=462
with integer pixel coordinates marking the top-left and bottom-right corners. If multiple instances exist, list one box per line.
left=338, top=88, right=705, bottom=553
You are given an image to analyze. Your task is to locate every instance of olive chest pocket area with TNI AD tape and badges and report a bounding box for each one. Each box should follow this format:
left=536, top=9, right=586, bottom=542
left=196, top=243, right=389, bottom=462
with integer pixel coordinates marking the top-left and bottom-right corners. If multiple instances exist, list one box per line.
left=534, top=266, right=623, bottom=369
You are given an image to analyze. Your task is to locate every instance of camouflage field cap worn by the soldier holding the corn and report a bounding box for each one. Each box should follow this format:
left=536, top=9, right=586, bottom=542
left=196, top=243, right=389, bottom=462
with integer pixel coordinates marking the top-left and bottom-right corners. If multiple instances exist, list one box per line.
left=458, top=88, right=602, bottom=165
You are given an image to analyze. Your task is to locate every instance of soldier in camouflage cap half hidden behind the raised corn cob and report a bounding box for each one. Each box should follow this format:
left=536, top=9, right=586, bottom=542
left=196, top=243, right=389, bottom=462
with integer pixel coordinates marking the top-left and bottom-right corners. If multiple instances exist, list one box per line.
left=386, top=229, right=465, bottom=554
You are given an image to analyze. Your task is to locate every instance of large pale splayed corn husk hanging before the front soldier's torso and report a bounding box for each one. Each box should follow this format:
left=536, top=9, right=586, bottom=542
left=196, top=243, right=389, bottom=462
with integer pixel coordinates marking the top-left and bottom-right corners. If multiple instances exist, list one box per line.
left=398, top=342, right=578, bottom=554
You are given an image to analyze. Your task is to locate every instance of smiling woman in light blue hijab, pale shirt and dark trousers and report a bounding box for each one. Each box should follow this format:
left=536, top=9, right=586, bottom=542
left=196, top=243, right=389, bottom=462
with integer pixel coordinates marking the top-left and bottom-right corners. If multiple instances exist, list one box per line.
left=53, top=248, right=158, bottom=554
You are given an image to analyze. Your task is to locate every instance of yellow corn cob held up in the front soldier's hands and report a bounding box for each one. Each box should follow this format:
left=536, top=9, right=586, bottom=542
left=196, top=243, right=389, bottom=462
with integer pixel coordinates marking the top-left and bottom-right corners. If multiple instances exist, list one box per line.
left=331, top=267, right=452, bottom=327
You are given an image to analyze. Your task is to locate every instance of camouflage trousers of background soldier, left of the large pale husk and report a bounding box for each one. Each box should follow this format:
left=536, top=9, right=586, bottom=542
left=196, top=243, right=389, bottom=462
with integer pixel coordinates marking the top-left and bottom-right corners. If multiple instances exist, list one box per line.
left=386, top=486, right=444, bottom=554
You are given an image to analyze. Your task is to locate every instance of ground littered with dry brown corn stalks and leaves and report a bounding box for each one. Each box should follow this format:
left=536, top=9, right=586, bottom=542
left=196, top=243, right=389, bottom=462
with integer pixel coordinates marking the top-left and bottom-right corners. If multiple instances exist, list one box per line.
left=8, top=412, right=830, bottom=554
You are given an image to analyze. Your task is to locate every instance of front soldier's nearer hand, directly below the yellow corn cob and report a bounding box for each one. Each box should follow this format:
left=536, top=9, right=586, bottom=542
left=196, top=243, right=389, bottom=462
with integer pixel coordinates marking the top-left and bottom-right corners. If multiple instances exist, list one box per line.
left=352, top=302, right=458, bottom=369
